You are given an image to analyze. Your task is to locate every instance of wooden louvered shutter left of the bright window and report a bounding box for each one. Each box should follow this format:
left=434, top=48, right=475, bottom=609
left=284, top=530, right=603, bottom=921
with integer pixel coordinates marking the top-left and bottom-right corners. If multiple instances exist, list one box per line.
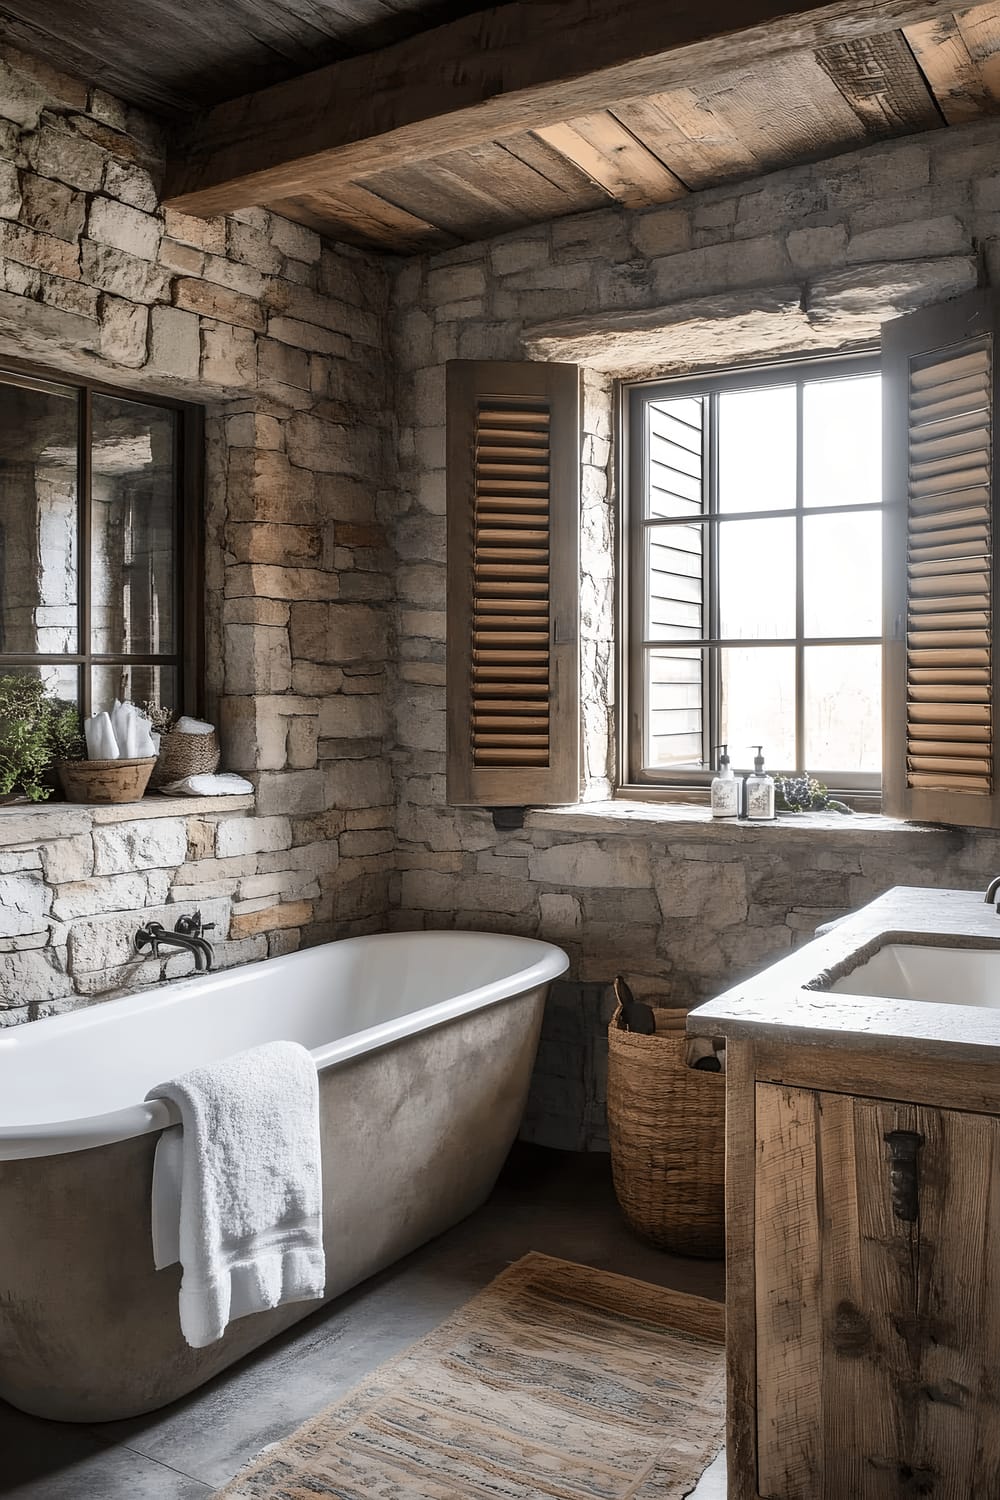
left=448, top=360, right=580, bottom=807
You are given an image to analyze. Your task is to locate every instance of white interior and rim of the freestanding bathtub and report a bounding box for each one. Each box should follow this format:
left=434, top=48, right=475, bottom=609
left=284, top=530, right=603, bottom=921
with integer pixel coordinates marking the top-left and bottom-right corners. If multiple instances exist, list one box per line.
left=0, top=933, right=565, bottom=1160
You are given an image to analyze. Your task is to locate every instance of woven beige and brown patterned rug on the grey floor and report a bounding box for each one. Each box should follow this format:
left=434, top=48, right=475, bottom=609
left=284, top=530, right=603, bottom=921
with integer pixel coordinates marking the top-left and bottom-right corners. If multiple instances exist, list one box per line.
left=219, top=1253, right=724, bottom=1500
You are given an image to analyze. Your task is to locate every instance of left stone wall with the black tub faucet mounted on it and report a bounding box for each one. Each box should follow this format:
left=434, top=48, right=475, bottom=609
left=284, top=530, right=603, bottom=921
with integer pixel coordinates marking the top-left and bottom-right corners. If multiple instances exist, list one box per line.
left=0, top=48, right=394, bottom=1025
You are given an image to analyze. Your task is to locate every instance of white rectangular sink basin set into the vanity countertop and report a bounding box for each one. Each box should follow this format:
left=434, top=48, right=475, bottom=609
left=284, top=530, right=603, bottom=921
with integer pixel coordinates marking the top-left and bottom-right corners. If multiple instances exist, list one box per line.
left=831, top=942, right=1000, bottom=1010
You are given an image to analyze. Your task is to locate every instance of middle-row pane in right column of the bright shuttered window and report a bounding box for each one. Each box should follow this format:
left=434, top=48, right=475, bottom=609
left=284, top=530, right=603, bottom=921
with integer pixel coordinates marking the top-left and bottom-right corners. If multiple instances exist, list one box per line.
left=802, top=510, right=882, bottom=636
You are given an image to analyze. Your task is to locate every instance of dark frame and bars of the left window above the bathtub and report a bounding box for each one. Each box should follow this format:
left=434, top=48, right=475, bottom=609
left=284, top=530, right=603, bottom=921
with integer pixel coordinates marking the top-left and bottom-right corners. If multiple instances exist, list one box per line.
left=0, top=356, right=205, bottom=719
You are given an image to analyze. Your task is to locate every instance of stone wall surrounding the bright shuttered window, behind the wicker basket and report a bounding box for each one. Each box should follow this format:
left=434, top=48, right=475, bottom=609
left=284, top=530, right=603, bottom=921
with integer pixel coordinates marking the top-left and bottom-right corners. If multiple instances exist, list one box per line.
left=393, top=123, right=1000, bottom=1148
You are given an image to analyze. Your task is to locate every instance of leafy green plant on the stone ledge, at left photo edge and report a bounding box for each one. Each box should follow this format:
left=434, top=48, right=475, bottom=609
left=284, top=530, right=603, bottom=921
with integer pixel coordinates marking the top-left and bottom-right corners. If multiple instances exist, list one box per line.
left=0, top=674, right=84, bottom=804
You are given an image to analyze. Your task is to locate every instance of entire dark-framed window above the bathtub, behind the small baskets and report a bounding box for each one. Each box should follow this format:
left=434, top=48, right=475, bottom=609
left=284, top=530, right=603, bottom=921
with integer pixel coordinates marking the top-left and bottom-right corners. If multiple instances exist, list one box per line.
left=0, top=360, right=201, bottom=716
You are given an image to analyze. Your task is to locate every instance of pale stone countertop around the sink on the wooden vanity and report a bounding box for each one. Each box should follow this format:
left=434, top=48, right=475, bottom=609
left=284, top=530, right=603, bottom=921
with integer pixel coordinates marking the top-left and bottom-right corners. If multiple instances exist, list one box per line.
left=688, top=885, right=1000, bottom=1062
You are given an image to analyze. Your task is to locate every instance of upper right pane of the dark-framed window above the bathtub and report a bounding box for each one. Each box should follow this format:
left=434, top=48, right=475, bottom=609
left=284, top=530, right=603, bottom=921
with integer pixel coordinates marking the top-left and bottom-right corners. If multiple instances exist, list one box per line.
left=90, top=395, right=177, bottom=656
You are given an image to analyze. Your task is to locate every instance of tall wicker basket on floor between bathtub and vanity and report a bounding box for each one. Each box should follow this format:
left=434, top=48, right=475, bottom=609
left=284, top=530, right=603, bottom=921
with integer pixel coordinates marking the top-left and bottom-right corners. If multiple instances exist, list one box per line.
left=607, top=1005, right=726, bottom=1260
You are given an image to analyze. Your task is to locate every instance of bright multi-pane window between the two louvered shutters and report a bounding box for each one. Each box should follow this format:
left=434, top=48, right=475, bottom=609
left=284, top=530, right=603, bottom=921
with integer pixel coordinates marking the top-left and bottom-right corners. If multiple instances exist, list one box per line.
left=627, top=357, right=883, bottom=789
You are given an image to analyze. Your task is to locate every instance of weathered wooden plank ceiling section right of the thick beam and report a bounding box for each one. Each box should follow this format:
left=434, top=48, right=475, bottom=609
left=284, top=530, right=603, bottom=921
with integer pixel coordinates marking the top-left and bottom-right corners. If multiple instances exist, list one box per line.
left=262, top=3, right=1000, bottom=254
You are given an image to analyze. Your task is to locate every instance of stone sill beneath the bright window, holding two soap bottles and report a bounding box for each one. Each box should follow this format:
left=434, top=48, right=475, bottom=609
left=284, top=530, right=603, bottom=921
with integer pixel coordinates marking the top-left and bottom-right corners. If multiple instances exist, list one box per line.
left=525, top=798, right=942, bottom=846
